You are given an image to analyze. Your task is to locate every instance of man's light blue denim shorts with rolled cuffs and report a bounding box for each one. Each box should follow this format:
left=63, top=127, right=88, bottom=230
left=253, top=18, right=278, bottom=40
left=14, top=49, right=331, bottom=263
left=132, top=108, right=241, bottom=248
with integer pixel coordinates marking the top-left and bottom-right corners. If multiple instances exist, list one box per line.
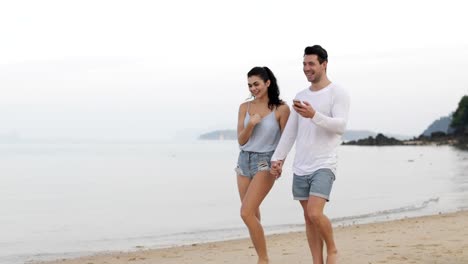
left=293, top=169, right=335, bottom=201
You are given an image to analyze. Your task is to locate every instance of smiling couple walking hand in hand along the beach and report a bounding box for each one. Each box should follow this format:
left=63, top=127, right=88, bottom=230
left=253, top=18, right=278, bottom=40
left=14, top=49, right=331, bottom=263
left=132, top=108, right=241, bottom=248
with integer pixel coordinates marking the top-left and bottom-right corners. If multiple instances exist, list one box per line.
left=236, top=45, right=349, bottom=264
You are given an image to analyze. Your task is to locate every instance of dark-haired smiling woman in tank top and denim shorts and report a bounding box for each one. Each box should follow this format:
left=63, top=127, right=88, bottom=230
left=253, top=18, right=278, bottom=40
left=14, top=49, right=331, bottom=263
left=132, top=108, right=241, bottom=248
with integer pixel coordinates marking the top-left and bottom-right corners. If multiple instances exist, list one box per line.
left=236, top=67, right=289, bottom=264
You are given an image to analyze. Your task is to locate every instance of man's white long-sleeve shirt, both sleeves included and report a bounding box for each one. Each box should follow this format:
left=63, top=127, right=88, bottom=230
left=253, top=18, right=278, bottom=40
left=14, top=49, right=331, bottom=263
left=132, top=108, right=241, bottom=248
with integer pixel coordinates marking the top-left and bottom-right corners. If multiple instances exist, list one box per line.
left=271, top=83, right=349, bottom=176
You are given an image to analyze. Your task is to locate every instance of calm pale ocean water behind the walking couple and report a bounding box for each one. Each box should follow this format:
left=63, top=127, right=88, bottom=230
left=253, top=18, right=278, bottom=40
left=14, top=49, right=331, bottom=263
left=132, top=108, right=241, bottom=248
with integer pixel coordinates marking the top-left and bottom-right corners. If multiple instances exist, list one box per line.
left=0, top=141, right=468, bottom=264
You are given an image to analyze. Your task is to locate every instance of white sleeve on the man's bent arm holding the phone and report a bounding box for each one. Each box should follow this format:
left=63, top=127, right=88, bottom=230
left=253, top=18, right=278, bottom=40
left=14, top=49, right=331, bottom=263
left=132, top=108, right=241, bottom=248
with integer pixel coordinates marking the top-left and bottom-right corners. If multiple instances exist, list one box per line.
left=311, top=89, right=349, bottom=135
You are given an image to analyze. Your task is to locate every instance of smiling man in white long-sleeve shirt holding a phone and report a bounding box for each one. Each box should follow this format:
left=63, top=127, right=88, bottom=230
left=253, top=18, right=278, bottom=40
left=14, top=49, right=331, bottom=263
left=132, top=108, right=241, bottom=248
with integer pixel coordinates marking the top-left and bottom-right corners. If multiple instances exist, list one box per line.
left=271, top=45, right=349, bottom=264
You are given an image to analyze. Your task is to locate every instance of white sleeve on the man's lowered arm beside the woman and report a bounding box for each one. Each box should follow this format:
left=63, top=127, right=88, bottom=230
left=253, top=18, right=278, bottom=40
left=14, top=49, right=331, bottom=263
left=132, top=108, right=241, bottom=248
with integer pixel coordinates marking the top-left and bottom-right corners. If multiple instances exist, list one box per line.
left=271, top=107, right=298, bottom=161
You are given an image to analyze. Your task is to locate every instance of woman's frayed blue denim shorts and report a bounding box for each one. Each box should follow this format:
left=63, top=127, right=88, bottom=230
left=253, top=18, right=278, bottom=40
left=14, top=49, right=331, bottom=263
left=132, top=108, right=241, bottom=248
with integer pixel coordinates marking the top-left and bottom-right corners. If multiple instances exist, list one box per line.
left=235, top=150, right=274, bottom=178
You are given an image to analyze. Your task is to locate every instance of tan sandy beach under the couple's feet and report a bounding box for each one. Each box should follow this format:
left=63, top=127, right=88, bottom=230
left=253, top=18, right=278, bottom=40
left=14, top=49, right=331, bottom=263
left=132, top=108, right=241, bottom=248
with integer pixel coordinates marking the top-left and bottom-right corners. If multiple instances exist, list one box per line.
left=35, top=211, right=468, bottom=264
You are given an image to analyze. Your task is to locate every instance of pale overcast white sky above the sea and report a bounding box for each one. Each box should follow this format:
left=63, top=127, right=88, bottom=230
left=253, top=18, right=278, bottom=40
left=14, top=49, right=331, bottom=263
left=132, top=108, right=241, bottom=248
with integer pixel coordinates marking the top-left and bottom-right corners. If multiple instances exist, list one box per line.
left=0, top=0, right=468, bottom=140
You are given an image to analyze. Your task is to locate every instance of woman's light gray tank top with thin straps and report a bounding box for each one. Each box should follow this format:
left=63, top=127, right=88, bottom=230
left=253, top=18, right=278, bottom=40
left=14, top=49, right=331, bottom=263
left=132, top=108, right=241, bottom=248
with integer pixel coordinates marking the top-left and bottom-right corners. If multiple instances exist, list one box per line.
left=240, top=103, right=281, bottom=153
